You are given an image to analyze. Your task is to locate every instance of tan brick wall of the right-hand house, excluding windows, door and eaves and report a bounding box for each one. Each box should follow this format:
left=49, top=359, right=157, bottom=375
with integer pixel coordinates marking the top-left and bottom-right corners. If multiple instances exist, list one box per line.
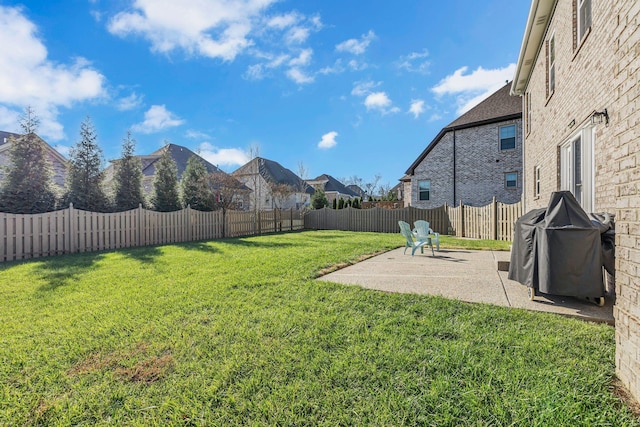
left=523, top=0, right=640, bottom=400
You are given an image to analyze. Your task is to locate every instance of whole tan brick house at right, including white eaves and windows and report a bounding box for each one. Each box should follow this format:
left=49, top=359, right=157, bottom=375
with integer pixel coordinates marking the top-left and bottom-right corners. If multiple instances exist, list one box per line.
left=511, top=0, right=640, bottom=399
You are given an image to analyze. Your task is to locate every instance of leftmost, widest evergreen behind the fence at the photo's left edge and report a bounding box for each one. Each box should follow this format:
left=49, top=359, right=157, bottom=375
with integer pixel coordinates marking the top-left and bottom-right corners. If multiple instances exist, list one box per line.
left=0, top=107, right=56, bottom=214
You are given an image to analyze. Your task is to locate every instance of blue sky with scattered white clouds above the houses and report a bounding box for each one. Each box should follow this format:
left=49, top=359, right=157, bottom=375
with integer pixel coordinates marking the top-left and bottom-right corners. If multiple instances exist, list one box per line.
left=0, top=0, right=530, bottom=186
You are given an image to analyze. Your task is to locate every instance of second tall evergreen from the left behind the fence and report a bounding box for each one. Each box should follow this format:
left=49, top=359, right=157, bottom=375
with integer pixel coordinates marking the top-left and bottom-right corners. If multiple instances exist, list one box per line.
left=65, top=116, right=107, bottom=212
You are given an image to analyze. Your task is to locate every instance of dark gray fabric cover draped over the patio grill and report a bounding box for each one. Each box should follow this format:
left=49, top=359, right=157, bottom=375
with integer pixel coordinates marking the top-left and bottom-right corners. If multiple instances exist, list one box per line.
left=509, top=191, right=606, bottom=298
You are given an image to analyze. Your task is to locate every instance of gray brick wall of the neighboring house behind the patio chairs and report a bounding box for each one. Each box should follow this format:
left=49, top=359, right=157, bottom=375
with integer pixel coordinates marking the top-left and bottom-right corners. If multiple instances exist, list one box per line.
left=408, top=119, right=522, bottom=208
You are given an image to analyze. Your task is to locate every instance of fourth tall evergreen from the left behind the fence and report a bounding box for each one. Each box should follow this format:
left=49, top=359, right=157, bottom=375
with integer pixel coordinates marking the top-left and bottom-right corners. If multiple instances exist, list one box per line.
left=151, top=143, right=180, bottom=212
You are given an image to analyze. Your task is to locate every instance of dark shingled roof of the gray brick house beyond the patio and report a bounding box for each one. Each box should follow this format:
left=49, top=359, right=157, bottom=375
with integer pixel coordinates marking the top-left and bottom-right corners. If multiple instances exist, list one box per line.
left=405, top=82, right=522, bottom=175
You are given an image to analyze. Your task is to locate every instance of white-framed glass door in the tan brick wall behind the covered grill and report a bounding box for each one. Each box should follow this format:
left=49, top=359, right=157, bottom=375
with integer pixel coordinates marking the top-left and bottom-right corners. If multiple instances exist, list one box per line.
left=560, top=127, right=594, bottom=212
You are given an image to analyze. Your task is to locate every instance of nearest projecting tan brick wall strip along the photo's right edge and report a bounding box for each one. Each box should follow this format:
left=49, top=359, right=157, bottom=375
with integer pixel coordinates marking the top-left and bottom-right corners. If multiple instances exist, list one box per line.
left=609, top=0, right=640, bottom=399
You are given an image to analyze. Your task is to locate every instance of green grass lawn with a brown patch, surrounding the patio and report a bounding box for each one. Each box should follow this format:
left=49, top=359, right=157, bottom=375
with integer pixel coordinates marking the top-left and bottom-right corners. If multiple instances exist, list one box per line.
left=0, top=231, right=640, bottom=426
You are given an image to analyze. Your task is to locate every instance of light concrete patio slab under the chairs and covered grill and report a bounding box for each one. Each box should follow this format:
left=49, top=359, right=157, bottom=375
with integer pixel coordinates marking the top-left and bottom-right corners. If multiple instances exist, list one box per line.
left=318, top=248, right=614, bottom=325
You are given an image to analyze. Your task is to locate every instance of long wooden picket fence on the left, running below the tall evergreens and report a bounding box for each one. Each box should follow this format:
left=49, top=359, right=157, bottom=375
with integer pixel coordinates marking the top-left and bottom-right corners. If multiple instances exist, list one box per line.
left=0, top=205, right=304, bottom=262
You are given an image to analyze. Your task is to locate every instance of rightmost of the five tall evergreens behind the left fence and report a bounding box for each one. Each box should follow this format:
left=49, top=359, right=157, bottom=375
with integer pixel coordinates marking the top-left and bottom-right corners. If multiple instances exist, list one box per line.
left=180, top=156, right=215, bottom=211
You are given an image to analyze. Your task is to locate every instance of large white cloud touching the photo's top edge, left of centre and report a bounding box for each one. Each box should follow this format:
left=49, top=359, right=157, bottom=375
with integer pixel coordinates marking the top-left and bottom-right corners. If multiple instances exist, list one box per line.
left=107, top=0, right=276, bottom=61
